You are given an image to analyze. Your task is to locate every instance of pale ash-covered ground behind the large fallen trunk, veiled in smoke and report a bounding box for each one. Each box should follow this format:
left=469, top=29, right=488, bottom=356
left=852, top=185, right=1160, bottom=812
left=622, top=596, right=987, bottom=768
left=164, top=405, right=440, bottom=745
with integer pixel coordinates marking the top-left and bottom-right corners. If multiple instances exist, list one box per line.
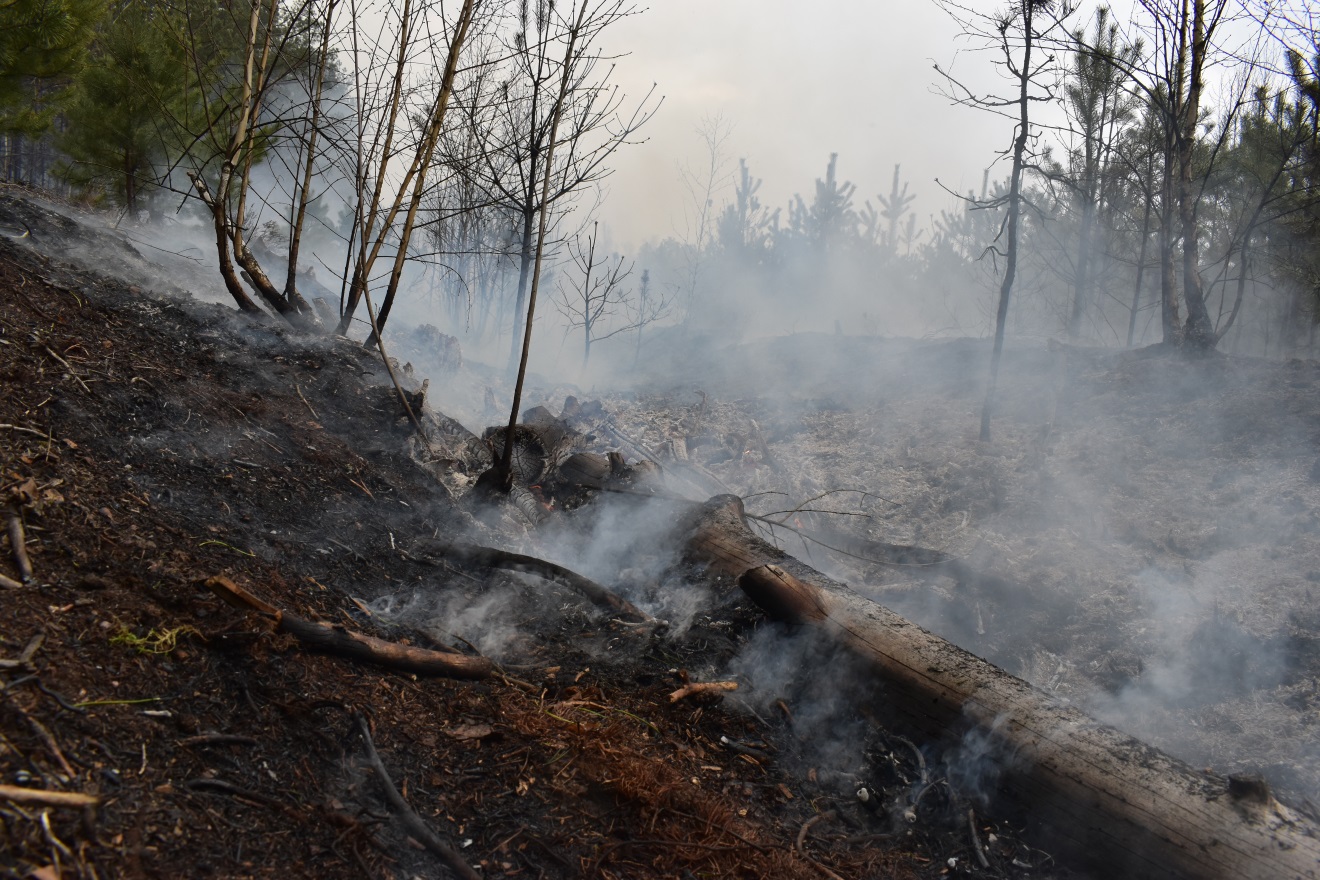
left=535, top=335, right=1320, bottom=802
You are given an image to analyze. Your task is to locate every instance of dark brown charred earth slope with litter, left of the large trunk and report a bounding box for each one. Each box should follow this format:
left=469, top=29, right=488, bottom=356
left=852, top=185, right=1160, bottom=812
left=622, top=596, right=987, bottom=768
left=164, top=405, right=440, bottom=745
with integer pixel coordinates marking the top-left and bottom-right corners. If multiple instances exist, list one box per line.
left=0, top=197, right=1045, bottom=879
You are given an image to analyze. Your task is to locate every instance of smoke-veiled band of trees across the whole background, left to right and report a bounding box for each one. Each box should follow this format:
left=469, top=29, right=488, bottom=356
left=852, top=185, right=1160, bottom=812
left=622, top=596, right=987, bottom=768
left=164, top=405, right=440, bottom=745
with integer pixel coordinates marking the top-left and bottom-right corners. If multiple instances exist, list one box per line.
left=0, top=0, right=1320, bottom=367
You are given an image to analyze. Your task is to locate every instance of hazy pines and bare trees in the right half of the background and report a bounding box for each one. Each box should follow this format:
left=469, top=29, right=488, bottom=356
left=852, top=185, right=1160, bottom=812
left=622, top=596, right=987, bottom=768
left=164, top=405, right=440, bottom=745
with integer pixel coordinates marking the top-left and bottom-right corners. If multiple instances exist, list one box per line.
left=638, top=0, right=1320, bottom=356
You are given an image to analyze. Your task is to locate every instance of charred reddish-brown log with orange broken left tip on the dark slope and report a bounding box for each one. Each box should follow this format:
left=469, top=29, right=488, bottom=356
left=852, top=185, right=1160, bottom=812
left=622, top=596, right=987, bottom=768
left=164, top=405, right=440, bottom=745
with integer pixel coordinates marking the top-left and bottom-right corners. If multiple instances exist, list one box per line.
left=206, top=577, right=495, bottom=679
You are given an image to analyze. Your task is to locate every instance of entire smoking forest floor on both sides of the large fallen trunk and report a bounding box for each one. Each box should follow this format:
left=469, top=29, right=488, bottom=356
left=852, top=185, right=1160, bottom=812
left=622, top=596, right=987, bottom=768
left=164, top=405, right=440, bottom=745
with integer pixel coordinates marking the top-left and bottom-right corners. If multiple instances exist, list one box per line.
left=0, top=187, right=1320, bottom=880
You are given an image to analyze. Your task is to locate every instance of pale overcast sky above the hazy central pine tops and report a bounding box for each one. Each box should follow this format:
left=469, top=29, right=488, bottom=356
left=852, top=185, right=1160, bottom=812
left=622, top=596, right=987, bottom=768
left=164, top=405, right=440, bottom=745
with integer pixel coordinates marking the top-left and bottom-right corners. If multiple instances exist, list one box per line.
left=603, top=0, right=1012, bottom=249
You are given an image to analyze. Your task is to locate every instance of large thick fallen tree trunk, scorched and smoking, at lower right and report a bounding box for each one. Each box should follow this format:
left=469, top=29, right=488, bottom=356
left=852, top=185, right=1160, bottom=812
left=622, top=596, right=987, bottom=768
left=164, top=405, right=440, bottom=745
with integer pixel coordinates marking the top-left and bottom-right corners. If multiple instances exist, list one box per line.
left=685, top=496, right=1320, bottom=880
